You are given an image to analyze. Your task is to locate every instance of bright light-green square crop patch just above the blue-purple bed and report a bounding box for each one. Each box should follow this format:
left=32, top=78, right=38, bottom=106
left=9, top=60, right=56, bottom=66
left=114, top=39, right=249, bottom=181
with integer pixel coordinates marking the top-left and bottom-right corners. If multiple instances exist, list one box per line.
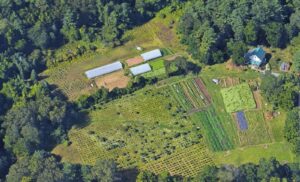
left=221, top=83, right=256, bottom=113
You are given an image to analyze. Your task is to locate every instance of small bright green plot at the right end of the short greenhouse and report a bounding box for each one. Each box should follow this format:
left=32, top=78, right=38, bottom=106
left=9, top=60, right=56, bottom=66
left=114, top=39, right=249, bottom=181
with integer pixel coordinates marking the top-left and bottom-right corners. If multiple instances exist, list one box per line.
left=142, top=59, right=167, bottom=78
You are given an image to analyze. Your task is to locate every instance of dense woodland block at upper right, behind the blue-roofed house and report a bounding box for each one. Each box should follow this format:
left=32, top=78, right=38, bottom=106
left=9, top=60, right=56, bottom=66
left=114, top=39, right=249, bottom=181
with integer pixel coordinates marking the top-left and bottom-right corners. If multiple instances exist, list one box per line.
left=179, top=0, right=300, bottom=65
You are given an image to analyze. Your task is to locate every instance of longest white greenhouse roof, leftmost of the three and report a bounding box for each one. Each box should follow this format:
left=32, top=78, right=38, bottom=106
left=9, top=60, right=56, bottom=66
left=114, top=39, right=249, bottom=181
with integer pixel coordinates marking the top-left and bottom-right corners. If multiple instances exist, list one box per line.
left=85, top=61, right=123, bottom=79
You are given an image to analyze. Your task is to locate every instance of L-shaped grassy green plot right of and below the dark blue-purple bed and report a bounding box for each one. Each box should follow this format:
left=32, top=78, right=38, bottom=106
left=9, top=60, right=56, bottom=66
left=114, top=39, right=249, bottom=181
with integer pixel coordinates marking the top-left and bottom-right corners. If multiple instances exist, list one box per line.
left=238, top=111, right=272, bottom=146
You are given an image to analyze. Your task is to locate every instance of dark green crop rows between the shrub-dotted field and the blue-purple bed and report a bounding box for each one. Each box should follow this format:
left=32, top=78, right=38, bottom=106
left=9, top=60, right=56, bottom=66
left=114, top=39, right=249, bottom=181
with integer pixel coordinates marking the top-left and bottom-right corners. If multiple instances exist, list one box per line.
left=191, top=107, right=234, bottom=151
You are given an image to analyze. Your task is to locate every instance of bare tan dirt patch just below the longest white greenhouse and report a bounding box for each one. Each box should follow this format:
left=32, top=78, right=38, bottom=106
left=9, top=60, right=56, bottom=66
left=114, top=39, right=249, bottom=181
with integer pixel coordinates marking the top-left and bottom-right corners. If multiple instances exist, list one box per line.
left=95, top=70, right=130, bottom=91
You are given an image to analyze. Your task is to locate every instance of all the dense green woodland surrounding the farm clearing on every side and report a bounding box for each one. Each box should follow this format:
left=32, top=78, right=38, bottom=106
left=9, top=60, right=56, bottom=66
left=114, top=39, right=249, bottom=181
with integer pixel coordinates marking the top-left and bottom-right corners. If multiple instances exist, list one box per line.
left=0, top=0, right=300, bottom=181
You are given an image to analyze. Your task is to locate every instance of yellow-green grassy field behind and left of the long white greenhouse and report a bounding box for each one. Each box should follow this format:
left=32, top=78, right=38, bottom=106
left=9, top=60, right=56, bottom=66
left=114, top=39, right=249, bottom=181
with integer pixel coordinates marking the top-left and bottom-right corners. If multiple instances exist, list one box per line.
left=41, top=8, right=184, bottom=100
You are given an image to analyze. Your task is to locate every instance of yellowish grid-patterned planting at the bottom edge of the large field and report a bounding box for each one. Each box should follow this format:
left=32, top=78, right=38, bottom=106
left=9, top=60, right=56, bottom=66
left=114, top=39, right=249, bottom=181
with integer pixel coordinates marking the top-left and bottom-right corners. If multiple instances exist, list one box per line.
left=142, top=143, right=214, bottom=176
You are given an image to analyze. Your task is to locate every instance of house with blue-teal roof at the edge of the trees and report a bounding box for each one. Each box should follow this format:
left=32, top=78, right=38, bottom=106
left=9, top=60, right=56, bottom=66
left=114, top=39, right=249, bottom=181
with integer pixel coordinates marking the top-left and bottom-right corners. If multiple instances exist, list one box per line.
left=244, top=47, right=267, bottom=68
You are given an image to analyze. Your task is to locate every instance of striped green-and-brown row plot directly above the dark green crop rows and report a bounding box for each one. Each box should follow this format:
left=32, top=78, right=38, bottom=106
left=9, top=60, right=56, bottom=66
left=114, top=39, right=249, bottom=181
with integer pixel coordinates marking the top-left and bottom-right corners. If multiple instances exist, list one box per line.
left=169, top=79, right=211, bottom=111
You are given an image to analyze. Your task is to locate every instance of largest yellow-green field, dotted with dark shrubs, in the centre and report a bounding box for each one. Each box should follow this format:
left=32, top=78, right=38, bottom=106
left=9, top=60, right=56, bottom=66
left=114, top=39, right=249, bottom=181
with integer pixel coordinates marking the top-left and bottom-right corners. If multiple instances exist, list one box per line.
left=54, top=86, right=202, bottom=168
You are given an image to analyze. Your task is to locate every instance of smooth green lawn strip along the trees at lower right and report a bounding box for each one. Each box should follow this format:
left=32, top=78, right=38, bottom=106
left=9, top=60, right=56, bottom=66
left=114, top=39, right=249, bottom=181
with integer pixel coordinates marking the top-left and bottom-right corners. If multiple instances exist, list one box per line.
left=214, top=142, right=295, bottom=166
